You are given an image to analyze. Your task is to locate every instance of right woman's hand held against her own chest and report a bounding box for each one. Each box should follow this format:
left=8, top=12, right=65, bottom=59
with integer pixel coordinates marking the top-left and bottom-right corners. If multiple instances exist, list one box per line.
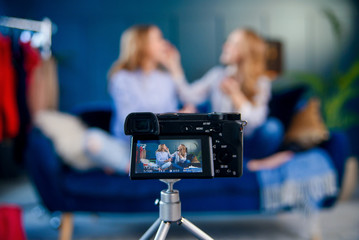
left=221, top=77, right=248, bottom=108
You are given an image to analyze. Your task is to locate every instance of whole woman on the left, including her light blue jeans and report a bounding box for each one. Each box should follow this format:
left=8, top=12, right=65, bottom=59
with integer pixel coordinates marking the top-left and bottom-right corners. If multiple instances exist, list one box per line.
left=85, top=25, right=187, bottom=172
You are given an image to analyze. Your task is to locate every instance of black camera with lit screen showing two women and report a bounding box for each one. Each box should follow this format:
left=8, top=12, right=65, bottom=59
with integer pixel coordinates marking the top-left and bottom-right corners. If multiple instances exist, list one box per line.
left=125, top=112, right=246, bottom=179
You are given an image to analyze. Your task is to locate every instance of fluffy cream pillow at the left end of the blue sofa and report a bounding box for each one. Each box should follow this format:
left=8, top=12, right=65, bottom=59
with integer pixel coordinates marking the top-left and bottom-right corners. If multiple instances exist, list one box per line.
left=34, top=111, right=95, bottom=170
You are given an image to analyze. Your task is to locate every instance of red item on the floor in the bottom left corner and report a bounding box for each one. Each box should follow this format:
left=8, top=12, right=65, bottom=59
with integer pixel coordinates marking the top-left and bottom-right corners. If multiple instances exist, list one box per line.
left=0, top=206, right=26, bottom=240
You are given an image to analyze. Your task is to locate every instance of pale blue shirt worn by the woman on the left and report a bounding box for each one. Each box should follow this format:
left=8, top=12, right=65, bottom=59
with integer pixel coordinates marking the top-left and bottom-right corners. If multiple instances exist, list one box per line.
left=109, top=70, right=178, bottom=138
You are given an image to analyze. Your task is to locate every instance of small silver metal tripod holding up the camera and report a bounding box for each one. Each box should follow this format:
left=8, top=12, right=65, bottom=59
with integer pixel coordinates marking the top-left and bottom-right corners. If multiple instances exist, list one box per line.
left=140, top=179, right=213, bottom=240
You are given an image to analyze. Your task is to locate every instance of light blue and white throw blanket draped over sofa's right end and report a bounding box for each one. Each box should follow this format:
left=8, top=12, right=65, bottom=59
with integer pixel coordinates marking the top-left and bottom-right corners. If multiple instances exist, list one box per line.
left=257, top=149, right=337, bottom=214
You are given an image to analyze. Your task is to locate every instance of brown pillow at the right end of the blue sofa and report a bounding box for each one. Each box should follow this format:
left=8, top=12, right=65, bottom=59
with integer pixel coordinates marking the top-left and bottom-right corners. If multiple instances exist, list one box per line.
left=284, top=98, right=329, bottom=150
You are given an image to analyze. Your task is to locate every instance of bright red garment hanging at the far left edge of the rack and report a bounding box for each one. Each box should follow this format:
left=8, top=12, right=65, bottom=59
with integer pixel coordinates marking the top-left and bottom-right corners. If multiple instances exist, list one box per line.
left=0, top=35, right=20, bottom=141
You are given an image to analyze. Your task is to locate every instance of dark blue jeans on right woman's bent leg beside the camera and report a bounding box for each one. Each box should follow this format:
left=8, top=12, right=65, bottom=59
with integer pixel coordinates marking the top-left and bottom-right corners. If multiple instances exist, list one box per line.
left=243, top=118, right=284, bottom=159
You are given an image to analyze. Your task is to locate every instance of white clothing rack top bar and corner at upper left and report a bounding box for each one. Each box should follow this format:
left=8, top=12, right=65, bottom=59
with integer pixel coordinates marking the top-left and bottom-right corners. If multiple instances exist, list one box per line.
left=0, top=16, right=56, bottom=59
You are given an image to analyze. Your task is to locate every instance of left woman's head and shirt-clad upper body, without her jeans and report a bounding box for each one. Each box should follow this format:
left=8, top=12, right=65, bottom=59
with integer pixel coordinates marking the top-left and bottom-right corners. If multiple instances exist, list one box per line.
left=108, top=25, right=178, bottom=138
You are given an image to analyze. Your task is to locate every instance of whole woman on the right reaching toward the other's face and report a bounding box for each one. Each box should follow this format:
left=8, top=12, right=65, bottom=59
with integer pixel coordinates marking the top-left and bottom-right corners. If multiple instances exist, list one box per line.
left=169, top=29, right=292, bottom=167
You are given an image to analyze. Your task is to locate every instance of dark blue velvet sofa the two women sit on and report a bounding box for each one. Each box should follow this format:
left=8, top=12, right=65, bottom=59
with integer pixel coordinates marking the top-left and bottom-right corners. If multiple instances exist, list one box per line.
left=26, top=88, right=349, bottom=238
